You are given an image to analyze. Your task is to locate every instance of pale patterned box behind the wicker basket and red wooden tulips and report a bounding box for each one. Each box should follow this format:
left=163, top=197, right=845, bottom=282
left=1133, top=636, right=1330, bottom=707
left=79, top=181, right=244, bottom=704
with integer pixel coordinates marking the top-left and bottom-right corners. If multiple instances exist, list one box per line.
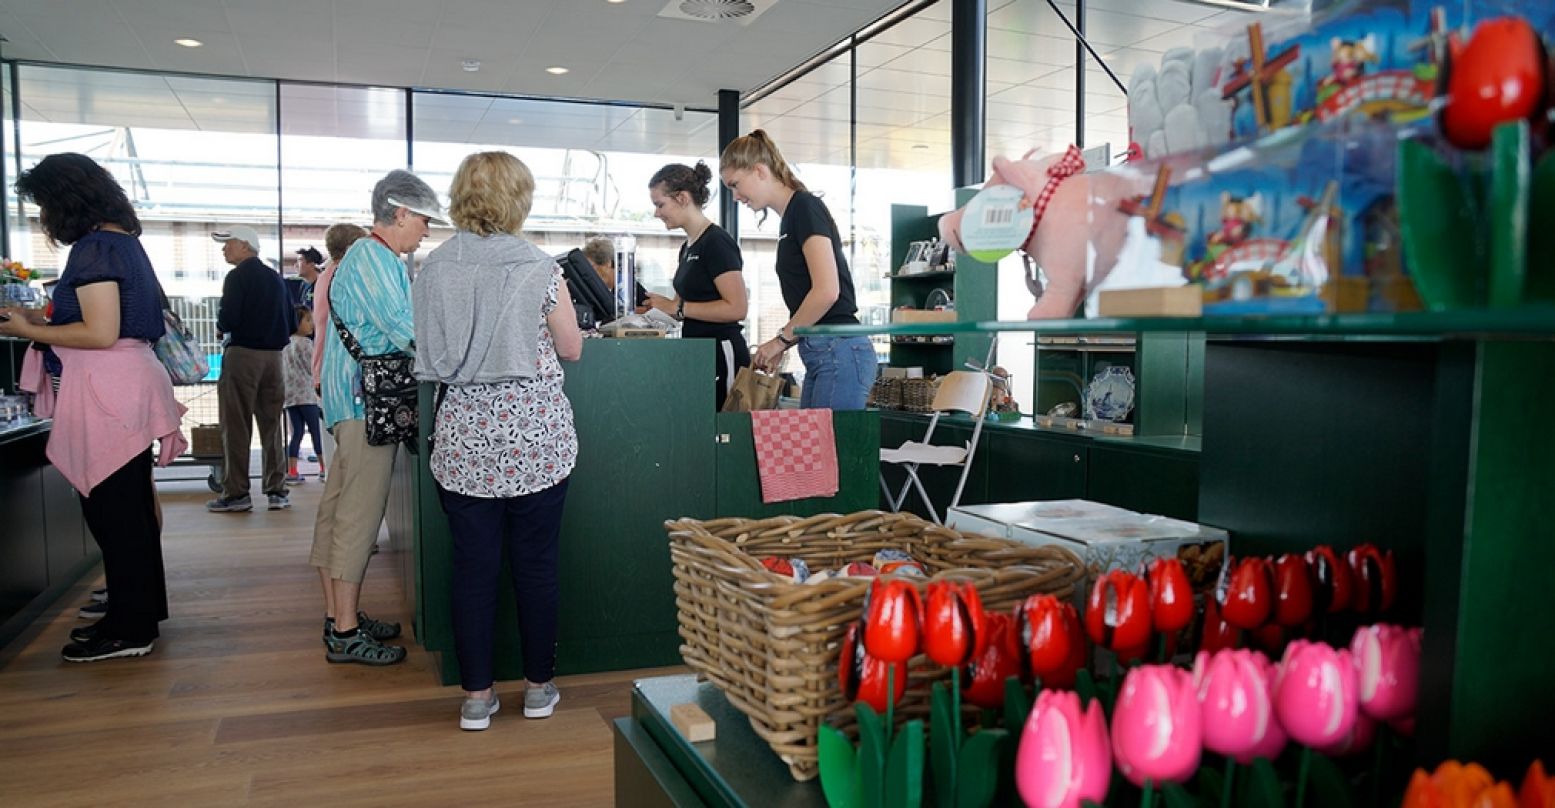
left=945, top=499, right=1230, bottom=600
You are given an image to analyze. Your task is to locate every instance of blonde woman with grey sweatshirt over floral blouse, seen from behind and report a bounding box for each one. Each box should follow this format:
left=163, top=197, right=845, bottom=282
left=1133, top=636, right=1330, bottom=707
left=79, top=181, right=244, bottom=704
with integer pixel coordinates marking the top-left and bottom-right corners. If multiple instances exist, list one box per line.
left=411, top=152, right=583, bottom=730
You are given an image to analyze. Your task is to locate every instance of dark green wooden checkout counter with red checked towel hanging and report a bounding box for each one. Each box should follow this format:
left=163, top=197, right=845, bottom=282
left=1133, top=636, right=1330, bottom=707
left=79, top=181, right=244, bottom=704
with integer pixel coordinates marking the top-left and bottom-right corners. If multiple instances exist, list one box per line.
left=389, top=339, right=880, bottom=684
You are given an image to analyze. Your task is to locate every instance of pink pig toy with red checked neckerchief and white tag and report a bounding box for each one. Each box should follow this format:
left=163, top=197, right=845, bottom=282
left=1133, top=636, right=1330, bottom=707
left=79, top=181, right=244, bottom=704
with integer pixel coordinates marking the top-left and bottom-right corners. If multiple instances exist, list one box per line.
left=939, top=146, right=1129, bottom=320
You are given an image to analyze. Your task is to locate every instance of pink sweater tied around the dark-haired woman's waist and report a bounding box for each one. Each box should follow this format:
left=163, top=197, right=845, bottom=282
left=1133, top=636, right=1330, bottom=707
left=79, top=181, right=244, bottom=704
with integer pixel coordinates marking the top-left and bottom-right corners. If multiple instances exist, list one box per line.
left=20, top=339, right=188, bottom=496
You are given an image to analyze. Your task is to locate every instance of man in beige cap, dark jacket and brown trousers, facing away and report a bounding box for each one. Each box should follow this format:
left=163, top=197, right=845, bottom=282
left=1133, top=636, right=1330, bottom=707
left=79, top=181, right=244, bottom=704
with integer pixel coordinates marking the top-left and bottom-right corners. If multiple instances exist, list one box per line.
left=205, top=225, right=297, bottom=513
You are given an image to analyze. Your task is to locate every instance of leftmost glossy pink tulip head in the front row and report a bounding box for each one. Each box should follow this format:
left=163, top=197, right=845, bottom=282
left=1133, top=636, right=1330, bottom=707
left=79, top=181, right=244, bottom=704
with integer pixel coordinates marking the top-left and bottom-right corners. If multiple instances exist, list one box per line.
left=1015, top=690, right=1112, bottom=808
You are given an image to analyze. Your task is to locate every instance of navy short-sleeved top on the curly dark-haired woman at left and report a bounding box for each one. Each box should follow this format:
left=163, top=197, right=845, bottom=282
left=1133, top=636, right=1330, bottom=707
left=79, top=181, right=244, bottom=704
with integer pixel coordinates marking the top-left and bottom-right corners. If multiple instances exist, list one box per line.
left=45, top=230, right=166, bottom=373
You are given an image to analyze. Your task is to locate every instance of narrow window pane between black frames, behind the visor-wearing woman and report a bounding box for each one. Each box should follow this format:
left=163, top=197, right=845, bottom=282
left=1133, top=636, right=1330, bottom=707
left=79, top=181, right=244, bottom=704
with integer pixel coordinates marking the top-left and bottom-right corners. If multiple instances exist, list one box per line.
left=281, top=84, right=406, bottom=275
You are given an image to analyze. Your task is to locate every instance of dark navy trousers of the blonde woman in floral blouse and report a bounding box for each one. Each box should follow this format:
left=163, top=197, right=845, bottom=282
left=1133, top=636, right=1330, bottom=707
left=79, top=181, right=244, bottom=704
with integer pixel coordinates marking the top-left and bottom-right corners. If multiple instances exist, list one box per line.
left=437, top=480, right=568, bottom=691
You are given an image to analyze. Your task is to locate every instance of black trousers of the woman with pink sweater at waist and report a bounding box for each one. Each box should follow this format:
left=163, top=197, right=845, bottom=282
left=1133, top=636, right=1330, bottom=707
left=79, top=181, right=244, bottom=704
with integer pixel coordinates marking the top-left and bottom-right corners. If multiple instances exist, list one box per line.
left=81, top=449, right=168, bottom=642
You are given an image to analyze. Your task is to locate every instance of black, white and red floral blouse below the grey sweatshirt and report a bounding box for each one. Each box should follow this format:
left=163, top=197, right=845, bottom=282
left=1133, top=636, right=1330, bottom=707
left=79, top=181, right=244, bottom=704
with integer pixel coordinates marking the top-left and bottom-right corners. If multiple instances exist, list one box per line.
left=431, top=267, right=578, bottom=499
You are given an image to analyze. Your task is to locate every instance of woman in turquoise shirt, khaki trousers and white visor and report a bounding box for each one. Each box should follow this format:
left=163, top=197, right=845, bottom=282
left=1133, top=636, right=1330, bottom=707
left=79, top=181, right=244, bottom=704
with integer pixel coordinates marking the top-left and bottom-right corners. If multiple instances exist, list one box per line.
left=309, top=171, right=443, bottom=665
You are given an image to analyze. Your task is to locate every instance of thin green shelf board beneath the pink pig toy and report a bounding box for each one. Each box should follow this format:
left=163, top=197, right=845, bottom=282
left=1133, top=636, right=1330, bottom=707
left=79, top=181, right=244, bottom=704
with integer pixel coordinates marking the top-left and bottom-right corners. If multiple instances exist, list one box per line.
left=796, top=306, right=1555, bottom=340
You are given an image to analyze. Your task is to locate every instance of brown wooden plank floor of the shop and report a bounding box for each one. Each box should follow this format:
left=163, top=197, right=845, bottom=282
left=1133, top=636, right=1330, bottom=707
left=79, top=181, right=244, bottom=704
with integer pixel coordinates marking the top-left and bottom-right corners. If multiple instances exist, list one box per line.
left=0, top=469, right=680, bottom=806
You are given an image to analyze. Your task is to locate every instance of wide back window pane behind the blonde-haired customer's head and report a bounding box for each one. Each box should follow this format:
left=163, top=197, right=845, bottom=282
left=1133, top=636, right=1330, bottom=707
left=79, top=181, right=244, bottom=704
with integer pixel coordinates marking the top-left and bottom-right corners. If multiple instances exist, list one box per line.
left=414, top=93, right=720, bottom=295
